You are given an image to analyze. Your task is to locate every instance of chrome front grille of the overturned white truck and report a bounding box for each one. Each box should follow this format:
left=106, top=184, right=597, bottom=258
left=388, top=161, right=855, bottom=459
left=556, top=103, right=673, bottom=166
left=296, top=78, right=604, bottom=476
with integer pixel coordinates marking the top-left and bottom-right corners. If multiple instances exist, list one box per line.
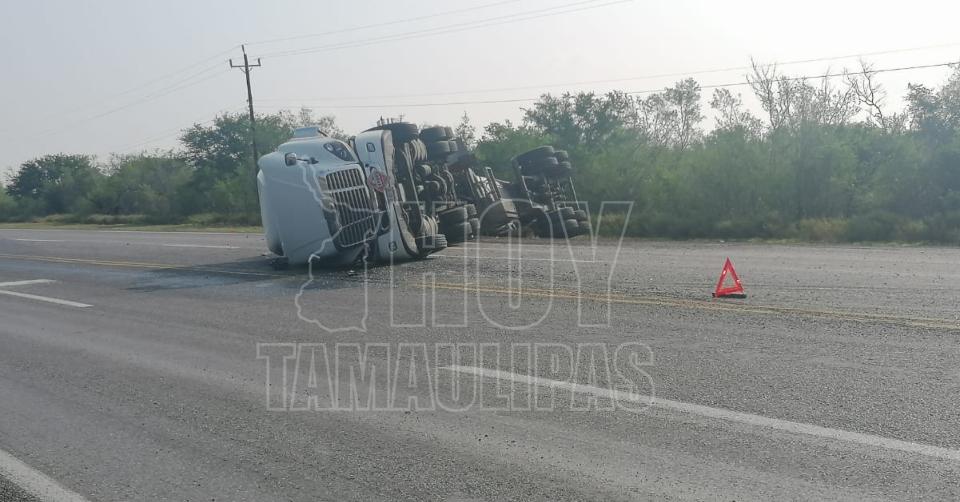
left=325, top=168, right=376, bottom=248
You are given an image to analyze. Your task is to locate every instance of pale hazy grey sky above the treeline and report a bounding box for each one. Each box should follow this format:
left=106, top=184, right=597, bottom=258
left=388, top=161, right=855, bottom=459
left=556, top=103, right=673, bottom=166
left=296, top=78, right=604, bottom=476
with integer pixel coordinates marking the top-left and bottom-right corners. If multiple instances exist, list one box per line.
left=0, top=0, right=960, bottom=177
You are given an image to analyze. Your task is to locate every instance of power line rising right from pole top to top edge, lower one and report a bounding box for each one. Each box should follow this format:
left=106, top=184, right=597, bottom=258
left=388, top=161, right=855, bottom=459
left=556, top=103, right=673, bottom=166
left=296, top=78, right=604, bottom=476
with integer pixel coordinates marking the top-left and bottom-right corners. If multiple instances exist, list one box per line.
left=261, top=0, right=633, bottom=58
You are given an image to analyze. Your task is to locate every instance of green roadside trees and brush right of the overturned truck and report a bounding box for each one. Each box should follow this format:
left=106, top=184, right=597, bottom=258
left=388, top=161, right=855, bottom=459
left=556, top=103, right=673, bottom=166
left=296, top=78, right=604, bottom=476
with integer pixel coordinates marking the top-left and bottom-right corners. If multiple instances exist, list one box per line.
left=478, top=65, right=960, bottom=244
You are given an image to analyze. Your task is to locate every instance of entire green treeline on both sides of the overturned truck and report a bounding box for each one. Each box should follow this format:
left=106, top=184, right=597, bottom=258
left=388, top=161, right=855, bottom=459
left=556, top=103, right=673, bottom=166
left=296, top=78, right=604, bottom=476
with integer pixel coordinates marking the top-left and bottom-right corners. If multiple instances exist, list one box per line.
left=0, top=61, right=960, bottom=244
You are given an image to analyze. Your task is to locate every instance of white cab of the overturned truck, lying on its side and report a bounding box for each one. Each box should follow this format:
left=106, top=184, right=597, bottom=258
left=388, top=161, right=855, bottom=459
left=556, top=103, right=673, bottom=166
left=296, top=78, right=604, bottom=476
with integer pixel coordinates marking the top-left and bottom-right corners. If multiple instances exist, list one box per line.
left=257, top=127, right=446, bottom=266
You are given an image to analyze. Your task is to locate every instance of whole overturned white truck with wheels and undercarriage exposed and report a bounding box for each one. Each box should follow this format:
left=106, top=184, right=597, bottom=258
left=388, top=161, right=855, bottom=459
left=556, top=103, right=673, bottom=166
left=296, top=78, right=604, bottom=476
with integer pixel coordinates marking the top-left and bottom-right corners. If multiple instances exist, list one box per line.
left=257, top=121, right=590, bottom=268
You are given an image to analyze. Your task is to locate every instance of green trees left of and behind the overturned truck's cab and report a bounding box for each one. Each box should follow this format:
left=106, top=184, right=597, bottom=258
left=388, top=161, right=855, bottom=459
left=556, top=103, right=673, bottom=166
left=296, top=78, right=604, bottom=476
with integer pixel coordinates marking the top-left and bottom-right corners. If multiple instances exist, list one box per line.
left=0, top=111, right=343, bottom=225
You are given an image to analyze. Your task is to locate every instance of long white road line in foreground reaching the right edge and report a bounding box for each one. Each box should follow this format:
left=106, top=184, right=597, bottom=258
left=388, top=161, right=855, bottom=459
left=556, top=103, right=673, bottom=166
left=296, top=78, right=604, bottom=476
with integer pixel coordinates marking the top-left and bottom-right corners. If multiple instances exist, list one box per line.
left=442, top=365, right=960, bottom=461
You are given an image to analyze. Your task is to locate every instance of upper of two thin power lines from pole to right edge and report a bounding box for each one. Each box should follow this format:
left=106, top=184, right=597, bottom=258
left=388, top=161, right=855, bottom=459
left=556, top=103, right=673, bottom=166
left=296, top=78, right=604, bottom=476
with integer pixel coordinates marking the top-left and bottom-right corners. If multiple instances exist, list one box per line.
left=260, top=43, right=960, bottom=101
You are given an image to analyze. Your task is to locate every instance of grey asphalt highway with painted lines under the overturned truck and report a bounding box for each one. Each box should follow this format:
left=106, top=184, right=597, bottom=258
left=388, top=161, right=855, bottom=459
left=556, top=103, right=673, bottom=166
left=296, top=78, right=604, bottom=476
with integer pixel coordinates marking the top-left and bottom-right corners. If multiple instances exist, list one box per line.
left=0, top=229, right=960, bottom=501
